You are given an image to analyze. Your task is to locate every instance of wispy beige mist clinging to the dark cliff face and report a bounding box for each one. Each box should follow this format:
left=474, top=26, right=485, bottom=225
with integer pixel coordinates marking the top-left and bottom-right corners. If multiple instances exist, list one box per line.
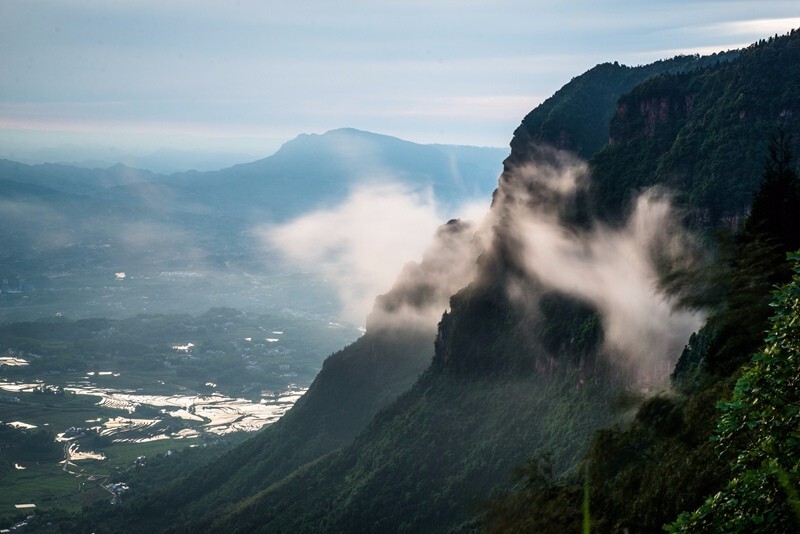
left=494, top=152, right=703, bottom=388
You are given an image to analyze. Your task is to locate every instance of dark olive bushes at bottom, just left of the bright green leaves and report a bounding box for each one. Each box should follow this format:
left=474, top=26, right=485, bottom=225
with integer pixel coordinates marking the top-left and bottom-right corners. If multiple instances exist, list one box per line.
left=486, top=378, right=727, bottom=533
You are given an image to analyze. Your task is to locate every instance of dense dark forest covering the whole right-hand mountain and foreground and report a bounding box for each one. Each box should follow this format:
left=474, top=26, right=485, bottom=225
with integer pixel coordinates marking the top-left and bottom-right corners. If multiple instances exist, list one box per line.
left=20, top=31, right=800, bottom=532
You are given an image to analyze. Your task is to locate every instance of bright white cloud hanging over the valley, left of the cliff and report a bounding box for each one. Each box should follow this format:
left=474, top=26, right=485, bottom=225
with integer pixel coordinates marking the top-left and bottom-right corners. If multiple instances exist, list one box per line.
left=257, top=183, right=478, bottom=324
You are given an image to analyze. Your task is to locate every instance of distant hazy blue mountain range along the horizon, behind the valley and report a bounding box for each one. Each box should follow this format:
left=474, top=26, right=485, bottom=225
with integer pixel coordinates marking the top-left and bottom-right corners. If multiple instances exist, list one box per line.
left=0, top=129, right=505, bottom=276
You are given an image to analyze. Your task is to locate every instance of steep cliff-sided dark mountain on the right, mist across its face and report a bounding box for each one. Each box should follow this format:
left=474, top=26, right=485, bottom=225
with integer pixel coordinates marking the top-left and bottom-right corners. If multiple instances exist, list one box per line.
left=37, top=32, right=800, bottom=532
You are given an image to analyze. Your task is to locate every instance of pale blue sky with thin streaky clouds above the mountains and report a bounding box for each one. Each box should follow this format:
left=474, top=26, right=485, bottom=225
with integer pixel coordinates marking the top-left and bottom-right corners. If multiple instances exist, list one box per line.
left=0, top=0, right=800, bottom=165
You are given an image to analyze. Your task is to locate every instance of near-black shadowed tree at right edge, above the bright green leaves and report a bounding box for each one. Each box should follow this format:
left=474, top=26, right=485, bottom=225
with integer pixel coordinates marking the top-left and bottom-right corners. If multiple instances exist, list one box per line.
left=675, top=129, right=800, bottom=378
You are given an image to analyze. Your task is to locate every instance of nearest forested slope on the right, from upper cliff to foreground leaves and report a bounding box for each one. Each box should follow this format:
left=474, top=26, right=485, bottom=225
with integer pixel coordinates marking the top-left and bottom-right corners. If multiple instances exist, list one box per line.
left=484, top=31, right=800, bottom=532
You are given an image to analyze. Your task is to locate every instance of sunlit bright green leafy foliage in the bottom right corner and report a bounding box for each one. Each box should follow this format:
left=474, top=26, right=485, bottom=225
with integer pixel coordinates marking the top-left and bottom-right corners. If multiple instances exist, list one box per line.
left=670, top=254, right=800, bottom=532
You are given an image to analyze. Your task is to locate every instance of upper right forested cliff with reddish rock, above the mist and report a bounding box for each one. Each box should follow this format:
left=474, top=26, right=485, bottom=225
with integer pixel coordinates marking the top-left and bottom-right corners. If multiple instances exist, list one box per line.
left=591, top=30, right=800, bottom=224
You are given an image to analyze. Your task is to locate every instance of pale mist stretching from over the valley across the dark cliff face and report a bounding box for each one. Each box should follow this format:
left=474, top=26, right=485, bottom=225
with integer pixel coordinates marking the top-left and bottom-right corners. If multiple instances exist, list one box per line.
left=260, top=144, right=703, bottom=383
